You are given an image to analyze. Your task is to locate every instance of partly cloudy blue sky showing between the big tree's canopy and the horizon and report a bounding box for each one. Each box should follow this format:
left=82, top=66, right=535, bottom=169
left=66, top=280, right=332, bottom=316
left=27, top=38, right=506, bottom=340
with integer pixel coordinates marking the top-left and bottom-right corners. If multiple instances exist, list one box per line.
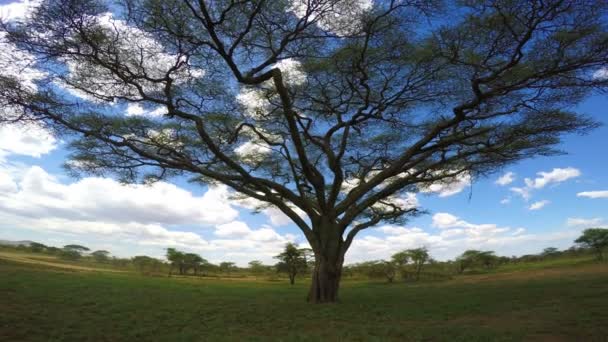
left=0, top=0, right=608, bottom=265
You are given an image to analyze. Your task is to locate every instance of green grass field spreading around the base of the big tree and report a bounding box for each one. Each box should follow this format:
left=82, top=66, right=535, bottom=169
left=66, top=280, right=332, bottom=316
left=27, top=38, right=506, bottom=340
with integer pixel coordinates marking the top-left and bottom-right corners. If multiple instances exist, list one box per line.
left=0, top=252, right=608, bottom=341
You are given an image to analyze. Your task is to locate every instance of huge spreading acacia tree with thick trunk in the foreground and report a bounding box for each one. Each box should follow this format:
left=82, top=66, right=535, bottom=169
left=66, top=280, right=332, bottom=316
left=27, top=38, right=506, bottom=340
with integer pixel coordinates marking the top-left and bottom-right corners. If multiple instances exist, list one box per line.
left=0, top=0, right=608, bottom=302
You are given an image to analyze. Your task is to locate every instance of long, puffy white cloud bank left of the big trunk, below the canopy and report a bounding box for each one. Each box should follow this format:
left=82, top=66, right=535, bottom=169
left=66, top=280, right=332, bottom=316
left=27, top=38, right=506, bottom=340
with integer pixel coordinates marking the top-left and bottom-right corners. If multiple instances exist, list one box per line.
left=0, top=166, right=238, bottom=225
